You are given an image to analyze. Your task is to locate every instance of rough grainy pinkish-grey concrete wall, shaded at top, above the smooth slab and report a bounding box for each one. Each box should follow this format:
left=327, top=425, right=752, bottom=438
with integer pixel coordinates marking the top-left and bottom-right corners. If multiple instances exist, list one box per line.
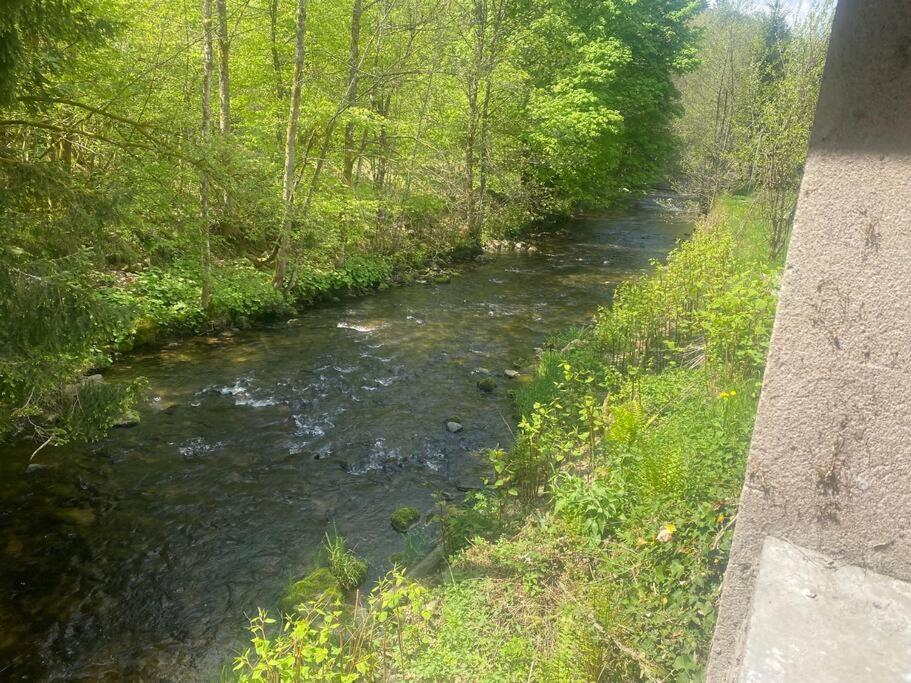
left=708, top=0, right=911, bottom=682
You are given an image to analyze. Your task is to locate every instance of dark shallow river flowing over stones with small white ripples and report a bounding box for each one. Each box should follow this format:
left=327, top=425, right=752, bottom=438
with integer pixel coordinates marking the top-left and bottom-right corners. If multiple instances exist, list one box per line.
left=0, top=198, right=692, bottom=681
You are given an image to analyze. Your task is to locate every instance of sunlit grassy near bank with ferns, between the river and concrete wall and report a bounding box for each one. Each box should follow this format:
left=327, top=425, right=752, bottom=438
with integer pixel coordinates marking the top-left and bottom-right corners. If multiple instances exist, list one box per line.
left=236, top=199, right=780, bottom=681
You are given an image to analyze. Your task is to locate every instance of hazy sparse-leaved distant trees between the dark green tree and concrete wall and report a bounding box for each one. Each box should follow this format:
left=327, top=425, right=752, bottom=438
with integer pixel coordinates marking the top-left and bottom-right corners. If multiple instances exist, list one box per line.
left=676, top=0, right=833, bottom=254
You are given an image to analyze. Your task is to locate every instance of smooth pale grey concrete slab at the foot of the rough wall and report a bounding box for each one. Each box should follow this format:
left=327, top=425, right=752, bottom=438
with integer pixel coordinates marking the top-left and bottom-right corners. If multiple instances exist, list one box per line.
left=740, top=536, right=911, bottom=683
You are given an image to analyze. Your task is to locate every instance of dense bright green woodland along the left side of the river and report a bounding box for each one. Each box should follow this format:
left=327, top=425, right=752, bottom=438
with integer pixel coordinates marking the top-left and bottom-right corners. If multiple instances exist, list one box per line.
left=0, top=0, right=700, bottom=448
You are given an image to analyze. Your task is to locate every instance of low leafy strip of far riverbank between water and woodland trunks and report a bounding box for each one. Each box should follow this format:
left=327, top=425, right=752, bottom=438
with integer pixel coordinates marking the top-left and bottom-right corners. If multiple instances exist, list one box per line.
left=0, top=224, right=542, bottom=447
